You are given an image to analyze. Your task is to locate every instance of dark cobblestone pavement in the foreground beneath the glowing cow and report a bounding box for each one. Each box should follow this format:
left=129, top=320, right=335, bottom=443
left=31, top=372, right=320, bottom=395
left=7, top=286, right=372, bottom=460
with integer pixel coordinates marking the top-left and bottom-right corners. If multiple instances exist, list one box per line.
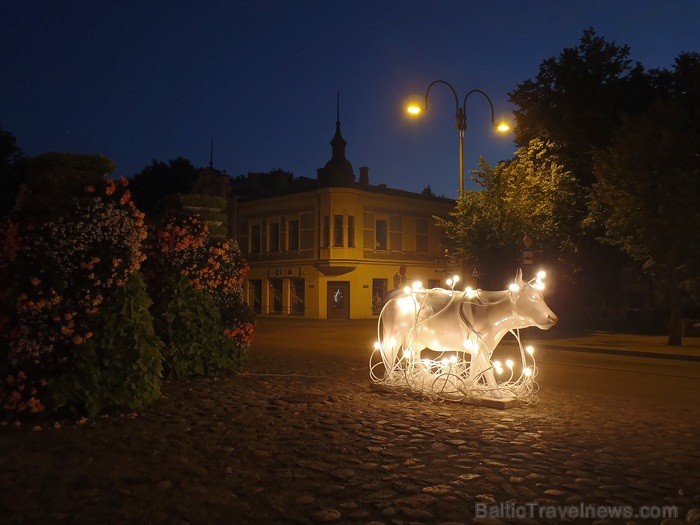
left=0, top=322, right=700, bottom=524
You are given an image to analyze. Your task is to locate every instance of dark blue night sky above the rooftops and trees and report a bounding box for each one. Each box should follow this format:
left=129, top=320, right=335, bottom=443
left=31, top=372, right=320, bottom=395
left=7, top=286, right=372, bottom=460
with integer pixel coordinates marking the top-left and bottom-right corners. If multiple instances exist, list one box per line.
left=0, top=0, right=700, bottom=196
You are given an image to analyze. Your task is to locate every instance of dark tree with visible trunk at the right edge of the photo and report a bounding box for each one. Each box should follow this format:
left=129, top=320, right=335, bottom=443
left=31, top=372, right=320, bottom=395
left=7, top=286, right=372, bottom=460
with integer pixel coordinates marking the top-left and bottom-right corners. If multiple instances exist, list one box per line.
left=589, top=53, right=700, bottom=345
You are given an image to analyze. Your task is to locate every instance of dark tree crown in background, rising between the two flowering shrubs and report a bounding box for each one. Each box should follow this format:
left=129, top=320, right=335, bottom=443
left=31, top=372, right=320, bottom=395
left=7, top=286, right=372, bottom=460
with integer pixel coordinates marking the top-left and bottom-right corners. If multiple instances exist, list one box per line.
left=130, top=157, right=199, bottom=215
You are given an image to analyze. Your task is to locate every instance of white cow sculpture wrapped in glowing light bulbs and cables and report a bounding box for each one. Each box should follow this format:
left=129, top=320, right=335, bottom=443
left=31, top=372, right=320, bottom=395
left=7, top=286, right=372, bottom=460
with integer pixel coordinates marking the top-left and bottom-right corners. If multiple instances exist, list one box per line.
left=370, top=270, right=557, bottom=402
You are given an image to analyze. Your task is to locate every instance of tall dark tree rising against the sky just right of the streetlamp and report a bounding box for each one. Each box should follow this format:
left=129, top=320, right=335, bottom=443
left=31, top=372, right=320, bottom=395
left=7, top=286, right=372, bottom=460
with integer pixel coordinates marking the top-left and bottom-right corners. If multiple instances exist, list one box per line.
left=510, top=28, right=655, bottom=187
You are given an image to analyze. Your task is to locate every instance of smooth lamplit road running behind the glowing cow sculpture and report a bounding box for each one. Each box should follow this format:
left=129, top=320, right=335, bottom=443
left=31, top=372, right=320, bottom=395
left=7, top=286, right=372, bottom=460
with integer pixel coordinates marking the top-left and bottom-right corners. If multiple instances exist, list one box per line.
left=253, top=318, right=700, bottom=415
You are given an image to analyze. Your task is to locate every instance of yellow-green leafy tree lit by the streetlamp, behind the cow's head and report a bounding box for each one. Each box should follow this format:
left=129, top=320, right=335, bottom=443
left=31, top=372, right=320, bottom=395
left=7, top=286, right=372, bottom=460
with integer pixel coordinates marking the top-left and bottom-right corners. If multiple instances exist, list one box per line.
left=438, top=139, right=584, bottom=286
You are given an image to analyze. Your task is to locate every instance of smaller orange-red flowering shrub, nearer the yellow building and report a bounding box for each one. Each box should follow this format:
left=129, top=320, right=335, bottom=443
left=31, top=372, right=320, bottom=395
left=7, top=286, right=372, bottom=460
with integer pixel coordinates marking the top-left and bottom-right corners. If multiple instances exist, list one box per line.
left=146, top=217, right=253, bottom=377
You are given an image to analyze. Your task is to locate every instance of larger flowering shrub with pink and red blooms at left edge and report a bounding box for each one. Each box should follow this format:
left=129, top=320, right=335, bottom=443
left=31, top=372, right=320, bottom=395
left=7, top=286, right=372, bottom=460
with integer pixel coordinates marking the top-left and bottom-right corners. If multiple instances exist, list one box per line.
left=0, top=174, right=160, bottom=413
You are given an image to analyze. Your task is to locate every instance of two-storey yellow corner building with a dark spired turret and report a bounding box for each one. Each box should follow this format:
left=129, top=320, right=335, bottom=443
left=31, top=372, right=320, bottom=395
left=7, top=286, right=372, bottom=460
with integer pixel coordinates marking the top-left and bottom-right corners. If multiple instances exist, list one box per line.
left=235, top=116, right=454, bottom=319
